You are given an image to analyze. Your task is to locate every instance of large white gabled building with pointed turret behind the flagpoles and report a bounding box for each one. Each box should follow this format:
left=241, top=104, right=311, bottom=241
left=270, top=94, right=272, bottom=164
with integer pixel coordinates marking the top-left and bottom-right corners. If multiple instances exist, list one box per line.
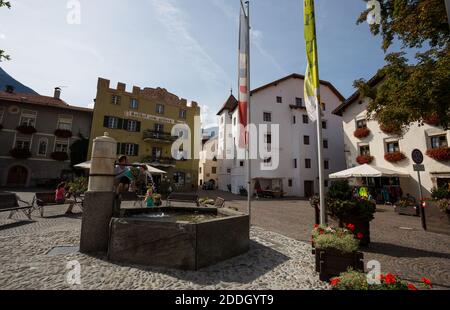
left=218, top=74, right=345, bottom=197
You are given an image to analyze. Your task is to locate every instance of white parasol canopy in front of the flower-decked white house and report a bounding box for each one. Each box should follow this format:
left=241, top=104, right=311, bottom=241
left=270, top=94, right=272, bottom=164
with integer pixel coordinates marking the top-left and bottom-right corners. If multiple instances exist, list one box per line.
left=329, top=164, right=410, bottom=179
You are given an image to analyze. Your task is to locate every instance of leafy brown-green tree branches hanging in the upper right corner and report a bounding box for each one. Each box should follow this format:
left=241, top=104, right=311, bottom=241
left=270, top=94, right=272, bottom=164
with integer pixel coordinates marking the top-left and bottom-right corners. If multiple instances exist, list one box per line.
left=354, top=0, right=450, bottom=131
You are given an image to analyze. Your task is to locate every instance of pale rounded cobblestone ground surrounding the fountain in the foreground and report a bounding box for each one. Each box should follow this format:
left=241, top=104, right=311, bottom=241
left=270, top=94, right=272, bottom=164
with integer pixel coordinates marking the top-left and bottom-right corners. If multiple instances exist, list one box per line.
left=0, top=194, right=329, bottom=290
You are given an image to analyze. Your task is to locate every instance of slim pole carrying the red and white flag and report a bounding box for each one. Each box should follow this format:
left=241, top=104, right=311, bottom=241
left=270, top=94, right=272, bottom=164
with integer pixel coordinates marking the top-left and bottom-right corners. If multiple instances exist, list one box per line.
left=245, top=1, right=252, bottom=225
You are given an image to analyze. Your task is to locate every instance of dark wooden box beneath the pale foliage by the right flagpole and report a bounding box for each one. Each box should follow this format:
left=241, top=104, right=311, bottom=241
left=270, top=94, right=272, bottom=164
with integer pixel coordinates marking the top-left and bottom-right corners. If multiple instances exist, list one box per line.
left=316, top=249, right=364, bottom=282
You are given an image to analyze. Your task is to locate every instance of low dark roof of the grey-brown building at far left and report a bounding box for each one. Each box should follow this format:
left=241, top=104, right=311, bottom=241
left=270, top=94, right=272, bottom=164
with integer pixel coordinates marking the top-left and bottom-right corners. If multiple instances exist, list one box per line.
left=0, top=91, right=92, bottom=113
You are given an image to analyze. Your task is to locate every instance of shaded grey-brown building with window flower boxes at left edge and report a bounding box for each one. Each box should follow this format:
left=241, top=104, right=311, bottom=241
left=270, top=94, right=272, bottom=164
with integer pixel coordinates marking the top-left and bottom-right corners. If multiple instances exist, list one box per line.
left=0, top=87, right=92, bottom=187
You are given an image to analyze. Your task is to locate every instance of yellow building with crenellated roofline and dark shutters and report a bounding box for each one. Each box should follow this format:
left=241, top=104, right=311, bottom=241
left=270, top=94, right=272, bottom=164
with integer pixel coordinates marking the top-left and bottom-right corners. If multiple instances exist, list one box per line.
left=89, top=78, right=200, bottom=191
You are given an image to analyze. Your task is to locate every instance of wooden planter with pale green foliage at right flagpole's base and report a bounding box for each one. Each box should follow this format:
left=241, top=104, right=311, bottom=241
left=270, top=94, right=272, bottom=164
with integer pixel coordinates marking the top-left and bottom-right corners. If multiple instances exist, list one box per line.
left=312, top=226, right=364, bottom=281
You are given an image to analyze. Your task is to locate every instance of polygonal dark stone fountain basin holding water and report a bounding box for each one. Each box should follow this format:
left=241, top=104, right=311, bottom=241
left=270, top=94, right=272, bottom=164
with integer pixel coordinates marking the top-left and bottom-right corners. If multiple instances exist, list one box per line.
left=108, top=207, right=250, bottom=270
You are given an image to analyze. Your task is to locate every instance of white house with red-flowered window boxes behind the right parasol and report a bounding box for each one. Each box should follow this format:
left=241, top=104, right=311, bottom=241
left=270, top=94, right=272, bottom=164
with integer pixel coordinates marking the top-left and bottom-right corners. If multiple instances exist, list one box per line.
left=334, top=77, right=450, bottom=198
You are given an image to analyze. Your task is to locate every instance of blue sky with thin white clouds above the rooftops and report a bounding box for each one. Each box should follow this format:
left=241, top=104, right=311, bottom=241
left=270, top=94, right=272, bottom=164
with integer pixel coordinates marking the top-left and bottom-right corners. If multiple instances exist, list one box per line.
left=0, top=0, right=398, bottom=127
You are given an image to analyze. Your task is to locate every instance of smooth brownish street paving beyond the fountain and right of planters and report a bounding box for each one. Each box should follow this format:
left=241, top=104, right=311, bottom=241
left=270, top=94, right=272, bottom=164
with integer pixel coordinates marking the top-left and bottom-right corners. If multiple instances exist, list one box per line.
left=201, top=191, right=450, bottom=289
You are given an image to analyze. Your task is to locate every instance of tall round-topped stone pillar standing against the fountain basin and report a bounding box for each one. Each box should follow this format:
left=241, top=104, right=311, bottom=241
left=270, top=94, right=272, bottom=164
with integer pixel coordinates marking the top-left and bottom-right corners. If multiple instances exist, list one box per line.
left=80, top=133, right=117, bottom=253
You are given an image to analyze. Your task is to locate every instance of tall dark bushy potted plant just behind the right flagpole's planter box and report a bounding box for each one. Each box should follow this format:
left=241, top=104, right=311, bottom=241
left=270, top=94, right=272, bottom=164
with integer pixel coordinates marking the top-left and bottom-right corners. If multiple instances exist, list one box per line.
left=326, top=181, right=376, bottom=245
